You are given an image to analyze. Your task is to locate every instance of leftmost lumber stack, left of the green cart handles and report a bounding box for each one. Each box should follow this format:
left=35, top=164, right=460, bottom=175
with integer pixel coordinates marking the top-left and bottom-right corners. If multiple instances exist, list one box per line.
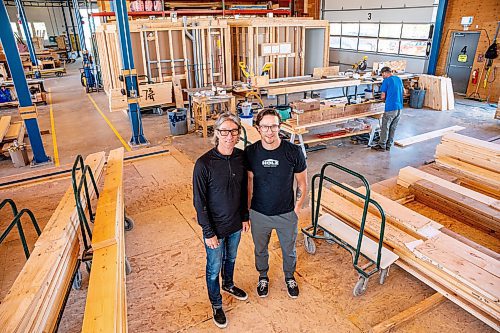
left=0, top=152, right=105, bottom=333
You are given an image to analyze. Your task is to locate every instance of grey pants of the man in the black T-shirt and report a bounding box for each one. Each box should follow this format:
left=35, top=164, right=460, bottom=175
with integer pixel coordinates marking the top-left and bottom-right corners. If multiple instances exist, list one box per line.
left=250, top=210, right=299, bottom=279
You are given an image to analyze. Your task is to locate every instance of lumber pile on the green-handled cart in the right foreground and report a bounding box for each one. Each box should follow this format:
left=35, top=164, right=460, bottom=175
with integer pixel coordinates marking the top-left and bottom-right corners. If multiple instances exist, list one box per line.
left=321, top=182, right=500, bottom=330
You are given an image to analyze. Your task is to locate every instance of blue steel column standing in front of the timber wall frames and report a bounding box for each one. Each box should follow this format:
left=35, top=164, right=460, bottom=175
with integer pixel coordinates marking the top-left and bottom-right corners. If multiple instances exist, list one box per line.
left=115, top=0, right=148, bottom=145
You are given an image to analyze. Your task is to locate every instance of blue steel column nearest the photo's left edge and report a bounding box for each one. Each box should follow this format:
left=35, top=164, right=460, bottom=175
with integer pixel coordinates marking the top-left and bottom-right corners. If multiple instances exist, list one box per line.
left=0, top=0, right=50, bottom=164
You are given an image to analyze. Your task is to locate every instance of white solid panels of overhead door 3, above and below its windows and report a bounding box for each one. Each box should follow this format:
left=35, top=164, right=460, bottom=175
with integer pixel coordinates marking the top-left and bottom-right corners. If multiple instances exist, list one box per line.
left=322, top=0, right=439, bottom=73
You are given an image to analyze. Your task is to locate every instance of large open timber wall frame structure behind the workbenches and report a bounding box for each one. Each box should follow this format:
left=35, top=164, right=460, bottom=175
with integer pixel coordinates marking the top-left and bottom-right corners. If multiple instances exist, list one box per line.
left=96, top=17, right=329, bottom=105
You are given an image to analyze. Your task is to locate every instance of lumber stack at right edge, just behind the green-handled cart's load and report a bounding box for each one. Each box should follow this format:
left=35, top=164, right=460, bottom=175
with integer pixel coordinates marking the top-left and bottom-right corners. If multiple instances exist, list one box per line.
left=398, top=167, right=500, bottom=233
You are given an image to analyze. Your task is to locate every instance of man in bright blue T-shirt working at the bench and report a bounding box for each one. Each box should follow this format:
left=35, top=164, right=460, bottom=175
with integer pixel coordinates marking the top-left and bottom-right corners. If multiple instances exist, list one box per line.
left=372, top=67, right=403, bottom=151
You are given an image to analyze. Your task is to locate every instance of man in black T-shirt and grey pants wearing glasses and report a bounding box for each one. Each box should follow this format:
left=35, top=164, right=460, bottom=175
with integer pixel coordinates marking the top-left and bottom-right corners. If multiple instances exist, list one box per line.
left=245, top=109, right=307, bottom=298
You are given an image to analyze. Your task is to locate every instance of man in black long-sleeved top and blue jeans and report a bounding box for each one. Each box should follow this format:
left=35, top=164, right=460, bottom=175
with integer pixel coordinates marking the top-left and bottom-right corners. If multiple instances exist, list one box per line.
left=193, top=113, right=250, bottom=328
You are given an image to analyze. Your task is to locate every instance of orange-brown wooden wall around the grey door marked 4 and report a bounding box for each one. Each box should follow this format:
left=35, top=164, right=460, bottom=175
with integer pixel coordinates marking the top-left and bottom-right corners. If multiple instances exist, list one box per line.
left=436, top=0, right=500, bottom=103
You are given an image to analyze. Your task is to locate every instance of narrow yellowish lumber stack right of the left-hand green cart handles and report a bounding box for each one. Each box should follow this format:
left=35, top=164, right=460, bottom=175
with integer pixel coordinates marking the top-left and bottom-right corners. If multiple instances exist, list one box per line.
left=82, top=147, right=127, bottom=333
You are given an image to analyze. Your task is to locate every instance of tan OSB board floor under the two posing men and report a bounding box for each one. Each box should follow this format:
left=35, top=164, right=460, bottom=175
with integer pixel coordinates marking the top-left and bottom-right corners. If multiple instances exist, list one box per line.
left=0, top=147, right=492, bottom=333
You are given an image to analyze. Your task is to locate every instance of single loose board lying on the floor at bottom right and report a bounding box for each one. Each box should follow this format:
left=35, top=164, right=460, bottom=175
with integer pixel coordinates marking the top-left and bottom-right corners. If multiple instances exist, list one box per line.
left=370, top=293, right=446, bottom=333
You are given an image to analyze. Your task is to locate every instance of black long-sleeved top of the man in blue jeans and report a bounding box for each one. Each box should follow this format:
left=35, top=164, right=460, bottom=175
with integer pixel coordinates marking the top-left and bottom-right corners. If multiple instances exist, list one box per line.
left=193, top=148, right=248, bottom=238
